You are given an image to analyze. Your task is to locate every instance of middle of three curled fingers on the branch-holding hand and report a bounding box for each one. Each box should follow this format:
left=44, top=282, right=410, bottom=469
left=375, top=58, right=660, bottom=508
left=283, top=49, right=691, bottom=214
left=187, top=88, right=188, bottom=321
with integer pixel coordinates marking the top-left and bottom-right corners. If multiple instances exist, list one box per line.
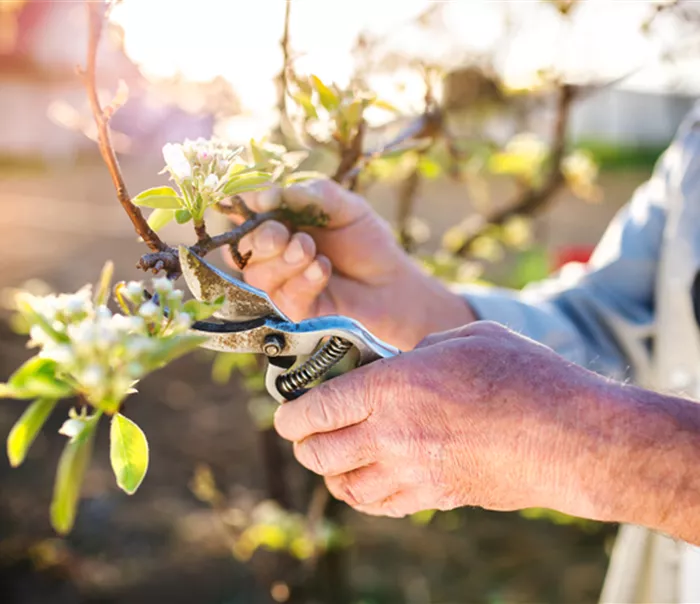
left=243, top=233, right=316, bottom=296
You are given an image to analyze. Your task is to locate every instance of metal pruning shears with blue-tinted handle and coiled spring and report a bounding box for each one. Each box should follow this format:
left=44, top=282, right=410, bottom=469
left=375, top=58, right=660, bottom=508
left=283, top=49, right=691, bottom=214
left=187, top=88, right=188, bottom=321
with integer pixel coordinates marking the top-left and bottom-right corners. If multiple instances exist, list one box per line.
left=179, top=246, right=399, bottom=403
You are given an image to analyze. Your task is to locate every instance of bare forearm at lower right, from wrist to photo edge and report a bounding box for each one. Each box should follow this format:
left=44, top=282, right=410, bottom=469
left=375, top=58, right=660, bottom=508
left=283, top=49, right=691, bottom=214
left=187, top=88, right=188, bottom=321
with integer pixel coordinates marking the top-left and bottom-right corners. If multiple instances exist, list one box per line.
left=564, top=382, right=700, bottom=544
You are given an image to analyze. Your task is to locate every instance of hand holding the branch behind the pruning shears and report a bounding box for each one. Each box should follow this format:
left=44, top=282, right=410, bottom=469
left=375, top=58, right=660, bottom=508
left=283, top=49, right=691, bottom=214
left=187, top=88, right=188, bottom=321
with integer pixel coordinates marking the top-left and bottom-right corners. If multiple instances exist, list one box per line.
left=230, top=180, right=474, bottom=350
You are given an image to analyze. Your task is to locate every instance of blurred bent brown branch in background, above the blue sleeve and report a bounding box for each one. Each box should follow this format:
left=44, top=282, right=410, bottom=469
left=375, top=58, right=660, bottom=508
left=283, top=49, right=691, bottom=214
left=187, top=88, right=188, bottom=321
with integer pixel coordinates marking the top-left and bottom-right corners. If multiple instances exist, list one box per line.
left=455, top=84, right=577, bottom=256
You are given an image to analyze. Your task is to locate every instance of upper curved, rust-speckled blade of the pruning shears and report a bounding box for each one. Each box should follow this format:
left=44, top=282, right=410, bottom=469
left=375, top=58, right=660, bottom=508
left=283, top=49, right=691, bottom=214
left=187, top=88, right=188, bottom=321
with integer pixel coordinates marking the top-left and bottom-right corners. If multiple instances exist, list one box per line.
left=179, top=245, right=291, bottom=323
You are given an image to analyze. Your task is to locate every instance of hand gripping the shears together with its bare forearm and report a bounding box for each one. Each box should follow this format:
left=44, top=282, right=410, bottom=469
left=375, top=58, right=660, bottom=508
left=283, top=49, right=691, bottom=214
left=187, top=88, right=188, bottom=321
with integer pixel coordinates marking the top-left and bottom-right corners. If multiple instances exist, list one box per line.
left=275, top=322, right=700, bottom=545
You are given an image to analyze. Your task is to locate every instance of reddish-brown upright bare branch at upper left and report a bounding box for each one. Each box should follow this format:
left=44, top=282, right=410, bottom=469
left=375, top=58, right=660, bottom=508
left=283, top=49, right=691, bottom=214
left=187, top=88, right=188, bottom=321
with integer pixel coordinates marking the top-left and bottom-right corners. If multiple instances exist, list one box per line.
left=79, top=0, right=168, bottom=252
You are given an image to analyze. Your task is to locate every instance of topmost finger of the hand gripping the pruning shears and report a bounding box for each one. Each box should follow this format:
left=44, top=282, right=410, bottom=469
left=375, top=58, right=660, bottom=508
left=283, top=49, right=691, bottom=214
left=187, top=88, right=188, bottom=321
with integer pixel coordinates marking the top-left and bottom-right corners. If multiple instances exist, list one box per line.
left=275, top=376, right=372, bottom=442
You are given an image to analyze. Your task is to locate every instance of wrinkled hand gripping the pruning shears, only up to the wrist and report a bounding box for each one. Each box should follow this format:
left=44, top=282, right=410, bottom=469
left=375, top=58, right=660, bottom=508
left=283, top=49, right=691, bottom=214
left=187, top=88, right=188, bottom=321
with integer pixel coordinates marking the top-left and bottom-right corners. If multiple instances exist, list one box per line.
left=275, top=322, right=604, bottom=517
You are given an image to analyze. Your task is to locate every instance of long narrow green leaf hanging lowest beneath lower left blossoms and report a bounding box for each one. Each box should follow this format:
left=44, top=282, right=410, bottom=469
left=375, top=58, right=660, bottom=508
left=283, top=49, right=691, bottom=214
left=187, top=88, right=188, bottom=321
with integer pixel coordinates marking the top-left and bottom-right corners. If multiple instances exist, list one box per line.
left=51, top=412, right=101, bottom=535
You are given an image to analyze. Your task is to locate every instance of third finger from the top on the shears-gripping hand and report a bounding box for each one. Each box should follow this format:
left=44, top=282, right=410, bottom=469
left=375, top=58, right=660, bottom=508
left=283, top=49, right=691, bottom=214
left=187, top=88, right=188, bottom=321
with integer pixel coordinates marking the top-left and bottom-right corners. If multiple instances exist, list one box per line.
left=325, top=464, right=400, bottom=507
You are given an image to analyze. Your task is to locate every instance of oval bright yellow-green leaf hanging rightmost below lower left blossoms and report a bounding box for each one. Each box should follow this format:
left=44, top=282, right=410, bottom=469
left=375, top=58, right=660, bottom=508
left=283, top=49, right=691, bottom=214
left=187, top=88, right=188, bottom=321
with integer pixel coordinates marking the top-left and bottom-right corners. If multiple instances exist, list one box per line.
left=109, top=413, right=148, bottom=495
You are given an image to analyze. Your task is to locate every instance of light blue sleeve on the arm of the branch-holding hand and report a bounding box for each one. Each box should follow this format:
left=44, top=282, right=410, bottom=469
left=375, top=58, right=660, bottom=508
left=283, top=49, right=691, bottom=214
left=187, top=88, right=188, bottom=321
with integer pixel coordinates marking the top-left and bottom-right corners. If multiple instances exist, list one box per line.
left=460, top=106, right=700, bottom=379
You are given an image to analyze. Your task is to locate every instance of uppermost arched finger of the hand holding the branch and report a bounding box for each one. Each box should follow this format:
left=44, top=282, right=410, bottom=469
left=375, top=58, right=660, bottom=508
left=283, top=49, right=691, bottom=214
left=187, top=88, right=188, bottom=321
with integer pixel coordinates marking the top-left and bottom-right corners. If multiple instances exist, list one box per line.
left=280, top=180, right=370, bottom=228
